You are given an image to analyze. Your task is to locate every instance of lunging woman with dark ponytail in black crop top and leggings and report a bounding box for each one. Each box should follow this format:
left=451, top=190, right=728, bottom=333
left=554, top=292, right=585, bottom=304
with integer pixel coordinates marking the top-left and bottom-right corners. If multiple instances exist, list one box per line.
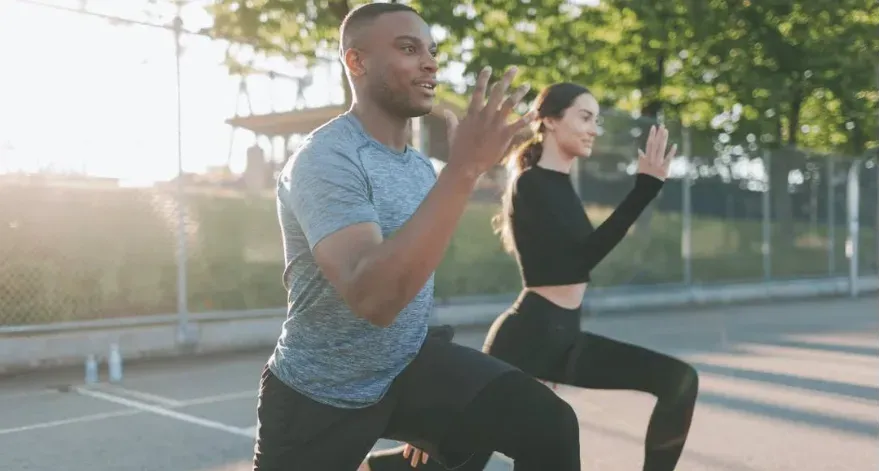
left=367, top=83, right=698, bottom=471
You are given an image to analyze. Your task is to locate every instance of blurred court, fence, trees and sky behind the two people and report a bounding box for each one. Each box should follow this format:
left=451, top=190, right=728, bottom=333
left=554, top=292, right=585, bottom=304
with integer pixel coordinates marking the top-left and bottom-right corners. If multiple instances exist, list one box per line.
left=0, top=0, right=880, bottom=471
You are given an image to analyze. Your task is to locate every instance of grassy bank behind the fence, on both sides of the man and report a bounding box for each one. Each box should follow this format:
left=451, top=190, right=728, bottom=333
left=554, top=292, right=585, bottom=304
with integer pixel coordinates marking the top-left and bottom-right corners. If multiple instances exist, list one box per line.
left=0, top=186, right=875, bottom=325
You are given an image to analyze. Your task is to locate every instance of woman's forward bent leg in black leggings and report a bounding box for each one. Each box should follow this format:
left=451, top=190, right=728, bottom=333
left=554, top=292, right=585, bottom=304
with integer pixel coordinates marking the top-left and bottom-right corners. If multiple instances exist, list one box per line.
left=543, top=333, right=698, bottom=471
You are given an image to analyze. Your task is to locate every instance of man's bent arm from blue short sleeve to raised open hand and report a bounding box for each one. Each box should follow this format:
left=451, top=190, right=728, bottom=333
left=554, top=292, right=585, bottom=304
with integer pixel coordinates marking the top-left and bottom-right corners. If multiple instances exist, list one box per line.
left=291, top=68, right=536, bottom=326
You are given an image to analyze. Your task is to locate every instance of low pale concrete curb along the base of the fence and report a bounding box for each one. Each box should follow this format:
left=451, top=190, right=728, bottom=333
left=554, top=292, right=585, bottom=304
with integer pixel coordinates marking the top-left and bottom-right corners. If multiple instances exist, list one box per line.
left=0, top=276, right=879, bottom=375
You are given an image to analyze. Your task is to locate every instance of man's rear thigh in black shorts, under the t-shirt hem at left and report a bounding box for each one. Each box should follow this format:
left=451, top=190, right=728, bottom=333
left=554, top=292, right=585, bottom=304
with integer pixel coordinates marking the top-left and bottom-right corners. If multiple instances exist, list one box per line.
left=252, top=368, right=392, bottom=471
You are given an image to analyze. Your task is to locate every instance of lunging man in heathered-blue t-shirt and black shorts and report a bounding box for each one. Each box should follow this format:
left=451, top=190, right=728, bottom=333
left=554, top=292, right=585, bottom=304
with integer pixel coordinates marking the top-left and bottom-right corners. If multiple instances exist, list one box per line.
left=253, top=3, right=580, bottom=471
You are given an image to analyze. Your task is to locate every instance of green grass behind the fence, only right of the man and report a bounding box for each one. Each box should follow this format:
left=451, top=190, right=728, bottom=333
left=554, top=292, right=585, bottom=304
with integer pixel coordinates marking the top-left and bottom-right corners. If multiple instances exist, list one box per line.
left=438, top=203, right=875, bottom=297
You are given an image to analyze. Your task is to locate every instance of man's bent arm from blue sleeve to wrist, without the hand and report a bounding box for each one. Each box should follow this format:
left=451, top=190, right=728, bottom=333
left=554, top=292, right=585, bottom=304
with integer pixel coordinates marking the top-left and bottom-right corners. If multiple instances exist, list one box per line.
left=283, top=149, right=476, bottom=327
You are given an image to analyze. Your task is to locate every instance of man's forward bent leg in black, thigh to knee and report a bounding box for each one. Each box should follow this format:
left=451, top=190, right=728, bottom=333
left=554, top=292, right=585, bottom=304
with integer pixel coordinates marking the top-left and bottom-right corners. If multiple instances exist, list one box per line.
left=384, top=339, right=580, bottom=471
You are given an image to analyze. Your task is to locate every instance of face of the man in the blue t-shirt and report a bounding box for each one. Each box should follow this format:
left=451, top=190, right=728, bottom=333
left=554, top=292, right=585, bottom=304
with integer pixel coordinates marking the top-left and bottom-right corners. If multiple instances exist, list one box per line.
left=363, top=12, right=438, bottom=118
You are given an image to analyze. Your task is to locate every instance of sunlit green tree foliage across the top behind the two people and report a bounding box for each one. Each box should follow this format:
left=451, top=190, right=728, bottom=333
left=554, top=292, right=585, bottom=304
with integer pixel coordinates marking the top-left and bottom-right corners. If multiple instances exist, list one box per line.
left=205, top=0, right=879, bottom=153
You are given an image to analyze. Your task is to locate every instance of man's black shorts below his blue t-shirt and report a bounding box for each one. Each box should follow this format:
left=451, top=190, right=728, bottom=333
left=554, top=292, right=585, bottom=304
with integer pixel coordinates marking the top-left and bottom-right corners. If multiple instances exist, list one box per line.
left=253, top=328, right=517, bottom=471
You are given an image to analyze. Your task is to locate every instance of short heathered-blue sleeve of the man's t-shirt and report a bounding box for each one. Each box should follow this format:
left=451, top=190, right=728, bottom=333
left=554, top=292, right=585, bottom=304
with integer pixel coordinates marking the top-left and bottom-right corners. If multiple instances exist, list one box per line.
left=279, top=149, right=379, bottom=250
